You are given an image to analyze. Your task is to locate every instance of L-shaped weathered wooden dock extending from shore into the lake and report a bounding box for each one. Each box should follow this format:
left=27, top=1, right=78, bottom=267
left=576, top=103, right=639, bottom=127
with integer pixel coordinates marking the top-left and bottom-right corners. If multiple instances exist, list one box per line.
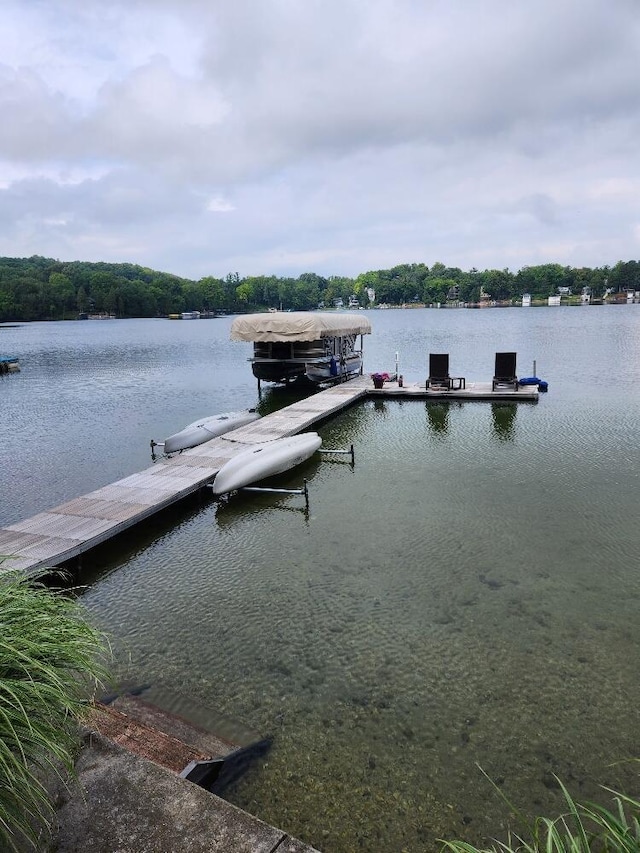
left=0, top=376, right=538, bottom=570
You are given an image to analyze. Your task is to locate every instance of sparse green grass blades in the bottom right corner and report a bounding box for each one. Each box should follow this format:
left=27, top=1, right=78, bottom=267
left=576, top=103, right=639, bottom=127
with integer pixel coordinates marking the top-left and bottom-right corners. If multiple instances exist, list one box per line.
left=442, top=779, right=640, bottom=853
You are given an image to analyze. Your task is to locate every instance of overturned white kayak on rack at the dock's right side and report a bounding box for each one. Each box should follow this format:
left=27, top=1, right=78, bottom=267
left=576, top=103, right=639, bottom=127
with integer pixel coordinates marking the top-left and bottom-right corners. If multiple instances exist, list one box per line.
left=213, top=432, right=322, bottom=495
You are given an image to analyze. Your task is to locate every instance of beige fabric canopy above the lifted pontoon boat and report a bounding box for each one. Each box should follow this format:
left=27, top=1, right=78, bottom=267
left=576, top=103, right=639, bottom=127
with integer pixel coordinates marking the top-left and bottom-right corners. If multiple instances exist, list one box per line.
left=231, top=311, right=371, bottom=342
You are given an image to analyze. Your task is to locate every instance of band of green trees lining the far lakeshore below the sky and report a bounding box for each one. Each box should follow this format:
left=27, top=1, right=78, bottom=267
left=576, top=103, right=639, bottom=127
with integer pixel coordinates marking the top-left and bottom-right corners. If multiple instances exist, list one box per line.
left=0, top=255, right=640, bottom=322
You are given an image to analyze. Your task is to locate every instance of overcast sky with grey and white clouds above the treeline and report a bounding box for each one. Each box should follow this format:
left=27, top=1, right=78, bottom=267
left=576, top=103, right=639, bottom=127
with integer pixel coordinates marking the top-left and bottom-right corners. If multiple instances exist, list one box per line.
left=0, top=0, right=640, bottom=279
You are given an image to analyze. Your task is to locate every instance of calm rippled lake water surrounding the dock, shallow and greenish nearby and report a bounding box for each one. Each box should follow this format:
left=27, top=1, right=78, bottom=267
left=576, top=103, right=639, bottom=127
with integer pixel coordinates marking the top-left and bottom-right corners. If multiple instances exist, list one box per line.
left=0, top=312, right=640, bottom=853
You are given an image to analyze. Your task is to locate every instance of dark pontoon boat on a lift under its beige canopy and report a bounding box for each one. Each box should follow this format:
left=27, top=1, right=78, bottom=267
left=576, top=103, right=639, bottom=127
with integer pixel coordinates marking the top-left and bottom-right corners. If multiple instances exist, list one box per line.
left=231, top=311, right=371, bottom=383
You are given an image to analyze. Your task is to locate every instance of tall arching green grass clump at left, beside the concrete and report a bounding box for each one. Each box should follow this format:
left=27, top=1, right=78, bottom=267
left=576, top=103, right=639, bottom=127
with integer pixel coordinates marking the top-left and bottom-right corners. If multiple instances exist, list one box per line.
left=0, top=560, right=107, bottom=850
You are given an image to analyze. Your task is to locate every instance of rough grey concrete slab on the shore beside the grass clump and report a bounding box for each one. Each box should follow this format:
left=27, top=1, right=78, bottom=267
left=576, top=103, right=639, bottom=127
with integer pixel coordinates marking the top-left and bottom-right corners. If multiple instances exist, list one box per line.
left=44, top=732, right=317, bottom=853
